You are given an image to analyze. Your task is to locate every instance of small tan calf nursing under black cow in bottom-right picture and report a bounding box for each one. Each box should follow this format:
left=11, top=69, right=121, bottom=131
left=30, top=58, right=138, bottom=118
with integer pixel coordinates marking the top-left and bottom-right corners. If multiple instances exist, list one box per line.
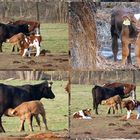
left=102, top=95, right=122, bottom=114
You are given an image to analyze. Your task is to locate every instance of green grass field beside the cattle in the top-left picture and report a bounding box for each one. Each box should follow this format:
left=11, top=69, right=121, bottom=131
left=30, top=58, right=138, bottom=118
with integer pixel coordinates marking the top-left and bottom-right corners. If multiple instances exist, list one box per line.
left=3, top=23, right=68, bottom=53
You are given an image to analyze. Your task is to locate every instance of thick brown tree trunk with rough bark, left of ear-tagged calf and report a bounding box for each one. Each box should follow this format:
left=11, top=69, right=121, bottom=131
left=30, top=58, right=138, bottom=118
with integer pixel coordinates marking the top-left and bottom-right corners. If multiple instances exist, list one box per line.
left=69, top=2, right=97, bottom=70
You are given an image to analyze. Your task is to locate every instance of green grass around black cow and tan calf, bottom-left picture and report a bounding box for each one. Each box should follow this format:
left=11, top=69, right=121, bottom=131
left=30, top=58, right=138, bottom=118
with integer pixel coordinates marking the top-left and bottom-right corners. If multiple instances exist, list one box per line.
left=0, top=80, right=68, bottom=136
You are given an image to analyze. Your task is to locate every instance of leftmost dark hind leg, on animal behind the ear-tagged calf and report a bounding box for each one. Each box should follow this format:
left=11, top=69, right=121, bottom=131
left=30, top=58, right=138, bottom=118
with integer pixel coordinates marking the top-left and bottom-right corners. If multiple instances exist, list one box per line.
left=112, top=35, right=118, bottom=61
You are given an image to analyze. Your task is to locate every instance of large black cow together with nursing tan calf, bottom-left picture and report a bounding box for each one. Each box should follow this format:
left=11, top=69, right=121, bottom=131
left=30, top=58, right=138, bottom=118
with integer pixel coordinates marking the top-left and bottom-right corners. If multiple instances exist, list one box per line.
left=0, top=81, right=55, bottom=132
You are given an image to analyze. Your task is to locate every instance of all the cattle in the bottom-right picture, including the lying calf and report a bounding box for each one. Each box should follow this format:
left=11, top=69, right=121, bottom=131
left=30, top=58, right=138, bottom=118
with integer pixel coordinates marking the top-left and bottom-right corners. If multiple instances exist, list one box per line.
left=73, top=82, right=140, bottom=119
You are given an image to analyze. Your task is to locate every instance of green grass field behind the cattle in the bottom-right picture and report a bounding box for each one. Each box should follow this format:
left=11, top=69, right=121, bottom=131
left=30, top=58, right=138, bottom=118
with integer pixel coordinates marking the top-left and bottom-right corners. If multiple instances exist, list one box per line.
left=71, top=84, right=140, bottom=116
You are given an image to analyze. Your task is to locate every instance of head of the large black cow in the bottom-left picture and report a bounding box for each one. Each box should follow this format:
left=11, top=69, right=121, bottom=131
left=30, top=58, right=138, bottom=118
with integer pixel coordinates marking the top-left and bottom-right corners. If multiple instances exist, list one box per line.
left=40, top=81, right=55, bottom=99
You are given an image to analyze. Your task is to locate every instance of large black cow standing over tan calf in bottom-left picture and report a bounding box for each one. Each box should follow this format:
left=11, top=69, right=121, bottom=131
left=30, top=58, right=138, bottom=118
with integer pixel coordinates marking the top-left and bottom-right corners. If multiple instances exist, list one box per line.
left=0, top=81, right=55, bottom=132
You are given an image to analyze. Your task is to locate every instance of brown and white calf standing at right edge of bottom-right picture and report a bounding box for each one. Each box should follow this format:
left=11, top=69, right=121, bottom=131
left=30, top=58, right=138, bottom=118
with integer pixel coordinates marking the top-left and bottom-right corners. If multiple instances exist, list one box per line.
left=122, top=100, right=140, bottom=119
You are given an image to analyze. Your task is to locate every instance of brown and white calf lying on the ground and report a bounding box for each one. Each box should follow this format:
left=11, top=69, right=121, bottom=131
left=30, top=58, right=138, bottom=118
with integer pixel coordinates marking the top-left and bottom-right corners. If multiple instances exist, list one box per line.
left=73, top=108, right=92, bottom=119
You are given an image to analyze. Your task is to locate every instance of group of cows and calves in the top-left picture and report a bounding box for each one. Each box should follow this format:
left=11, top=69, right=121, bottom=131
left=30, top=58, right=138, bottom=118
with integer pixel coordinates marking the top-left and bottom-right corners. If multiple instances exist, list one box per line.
left=0, top=20, right=42, bottom=57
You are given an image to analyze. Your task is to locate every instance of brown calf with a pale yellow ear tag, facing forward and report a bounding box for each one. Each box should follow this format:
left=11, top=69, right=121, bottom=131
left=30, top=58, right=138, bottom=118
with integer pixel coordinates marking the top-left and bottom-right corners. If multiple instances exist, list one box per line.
left=121, top=15, right=140, bottom=67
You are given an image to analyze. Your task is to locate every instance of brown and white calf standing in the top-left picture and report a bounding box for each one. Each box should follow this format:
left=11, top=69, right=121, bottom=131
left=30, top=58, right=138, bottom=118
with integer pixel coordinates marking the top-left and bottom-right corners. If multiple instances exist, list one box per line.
left=21, top=34, right=42, bottom=57
